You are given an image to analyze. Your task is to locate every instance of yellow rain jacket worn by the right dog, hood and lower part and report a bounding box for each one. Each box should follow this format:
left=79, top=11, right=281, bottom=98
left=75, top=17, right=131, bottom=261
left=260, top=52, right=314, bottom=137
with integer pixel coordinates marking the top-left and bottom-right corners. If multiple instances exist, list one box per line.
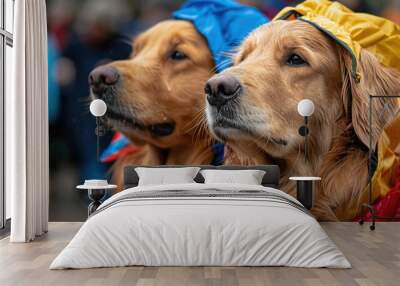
left=274, top=0, right=400, bottom=217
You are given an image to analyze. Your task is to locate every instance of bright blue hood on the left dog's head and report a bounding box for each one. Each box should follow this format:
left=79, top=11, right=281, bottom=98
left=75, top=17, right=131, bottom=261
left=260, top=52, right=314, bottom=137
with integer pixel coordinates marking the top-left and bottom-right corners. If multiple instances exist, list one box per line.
left=173, top=0, right=269, bottom=72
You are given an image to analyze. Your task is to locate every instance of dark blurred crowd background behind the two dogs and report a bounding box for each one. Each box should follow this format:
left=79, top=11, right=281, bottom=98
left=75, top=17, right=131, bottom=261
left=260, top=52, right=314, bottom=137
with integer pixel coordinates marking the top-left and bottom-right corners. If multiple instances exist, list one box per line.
left=47, top=0, right=400, bottom=221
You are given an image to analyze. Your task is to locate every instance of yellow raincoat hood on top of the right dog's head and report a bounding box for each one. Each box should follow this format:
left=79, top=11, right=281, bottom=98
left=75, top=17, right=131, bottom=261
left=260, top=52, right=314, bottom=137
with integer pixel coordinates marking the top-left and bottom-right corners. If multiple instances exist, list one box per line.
left=274, top=0, right=400, bottom=79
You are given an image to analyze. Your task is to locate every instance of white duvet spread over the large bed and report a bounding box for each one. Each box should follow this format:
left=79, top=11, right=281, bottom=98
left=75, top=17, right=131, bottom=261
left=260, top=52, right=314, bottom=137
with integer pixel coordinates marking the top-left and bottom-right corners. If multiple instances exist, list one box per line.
left=50, top=184, right=351, bottom=269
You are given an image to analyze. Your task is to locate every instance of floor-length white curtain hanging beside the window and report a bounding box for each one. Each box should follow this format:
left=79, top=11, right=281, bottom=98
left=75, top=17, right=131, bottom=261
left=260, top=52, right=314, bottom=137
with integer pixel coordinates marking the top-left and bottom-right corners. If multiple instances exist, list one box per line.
left=5, top=0, right=49, bottom=242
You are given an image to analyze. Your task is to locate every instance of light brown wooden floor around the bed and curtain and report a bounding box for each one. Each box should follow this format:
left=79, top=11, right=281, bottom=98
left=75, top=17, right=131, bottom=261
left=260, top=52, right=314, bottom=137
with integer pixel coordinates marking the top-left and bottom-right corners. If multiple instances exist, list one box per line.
left=0, top=222, right=400, bottom=286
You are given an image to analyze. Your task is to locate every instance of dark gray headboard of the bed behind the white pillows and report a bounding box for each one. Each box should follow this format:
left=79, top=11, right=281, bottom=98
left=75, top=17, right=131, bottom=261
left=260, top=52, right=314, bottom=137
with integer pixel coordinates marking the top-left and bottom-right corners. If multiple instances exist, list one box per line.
left=124, top=165, right=280, bottom=189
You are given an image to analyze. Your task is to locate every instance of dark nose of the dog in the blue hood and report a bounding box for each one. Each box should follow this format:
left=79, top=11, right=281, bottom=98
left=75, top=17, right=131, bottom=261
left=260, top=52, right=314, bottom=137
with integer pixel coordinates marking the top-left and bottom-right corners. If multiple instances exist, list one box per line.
left=89, top=66, right=119, bottom=96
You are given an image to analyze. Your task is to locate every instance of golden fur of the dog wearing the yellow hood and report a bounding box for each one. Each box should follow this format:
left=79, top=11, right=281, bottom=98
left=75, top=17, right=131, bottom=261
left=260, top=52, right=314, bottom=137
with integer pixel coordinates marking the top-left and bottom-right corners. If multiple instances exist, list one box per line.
left=207, top=20, right=400, bottom=220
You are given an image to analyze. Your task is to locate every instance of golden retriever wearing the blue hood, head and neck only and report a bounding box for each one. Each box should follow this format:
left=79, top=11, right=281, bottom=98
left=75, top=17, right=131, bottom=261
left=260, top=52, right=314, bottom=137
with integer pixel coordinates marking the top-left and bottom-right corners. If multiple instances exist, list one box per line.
left=89, top=20, right=214, bottom=190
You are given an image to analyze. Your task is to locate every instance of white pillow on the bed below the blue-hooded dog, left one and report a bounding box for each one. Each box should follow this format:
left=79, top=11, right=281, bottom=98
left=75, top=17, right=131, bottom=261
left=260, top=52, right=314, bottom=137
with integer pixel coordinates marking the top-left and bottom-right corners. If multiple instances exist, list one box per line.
left=135, top=167, right=200, bottom=186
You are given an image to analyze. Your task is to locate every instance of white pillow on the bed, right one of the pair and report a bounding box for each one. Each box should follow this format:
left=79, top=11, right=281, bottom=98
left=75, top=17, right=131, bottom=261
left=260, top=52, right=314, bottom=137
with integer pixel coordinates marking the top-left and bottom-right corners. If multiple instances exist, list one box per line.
left=200, top=170, right=265, bottom=185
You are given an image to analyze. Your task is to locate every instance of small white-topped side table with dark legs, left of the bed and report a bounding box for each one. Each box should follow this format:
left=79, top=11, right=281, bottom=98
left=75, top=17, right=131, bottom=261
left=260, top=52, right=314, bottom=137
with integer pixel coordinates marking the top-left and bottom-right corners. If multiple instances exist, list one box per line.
left=76, top=180, right=117, bottom=217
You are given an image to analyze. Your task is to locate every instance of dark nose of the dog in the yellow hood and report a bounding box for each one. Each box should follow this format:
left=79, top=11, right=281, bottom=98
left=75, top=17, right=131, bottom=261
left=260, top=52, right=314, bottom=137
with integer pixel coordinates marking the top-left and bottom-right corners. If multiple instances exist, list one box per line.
left=204, top=74, right=242, bottom=107
